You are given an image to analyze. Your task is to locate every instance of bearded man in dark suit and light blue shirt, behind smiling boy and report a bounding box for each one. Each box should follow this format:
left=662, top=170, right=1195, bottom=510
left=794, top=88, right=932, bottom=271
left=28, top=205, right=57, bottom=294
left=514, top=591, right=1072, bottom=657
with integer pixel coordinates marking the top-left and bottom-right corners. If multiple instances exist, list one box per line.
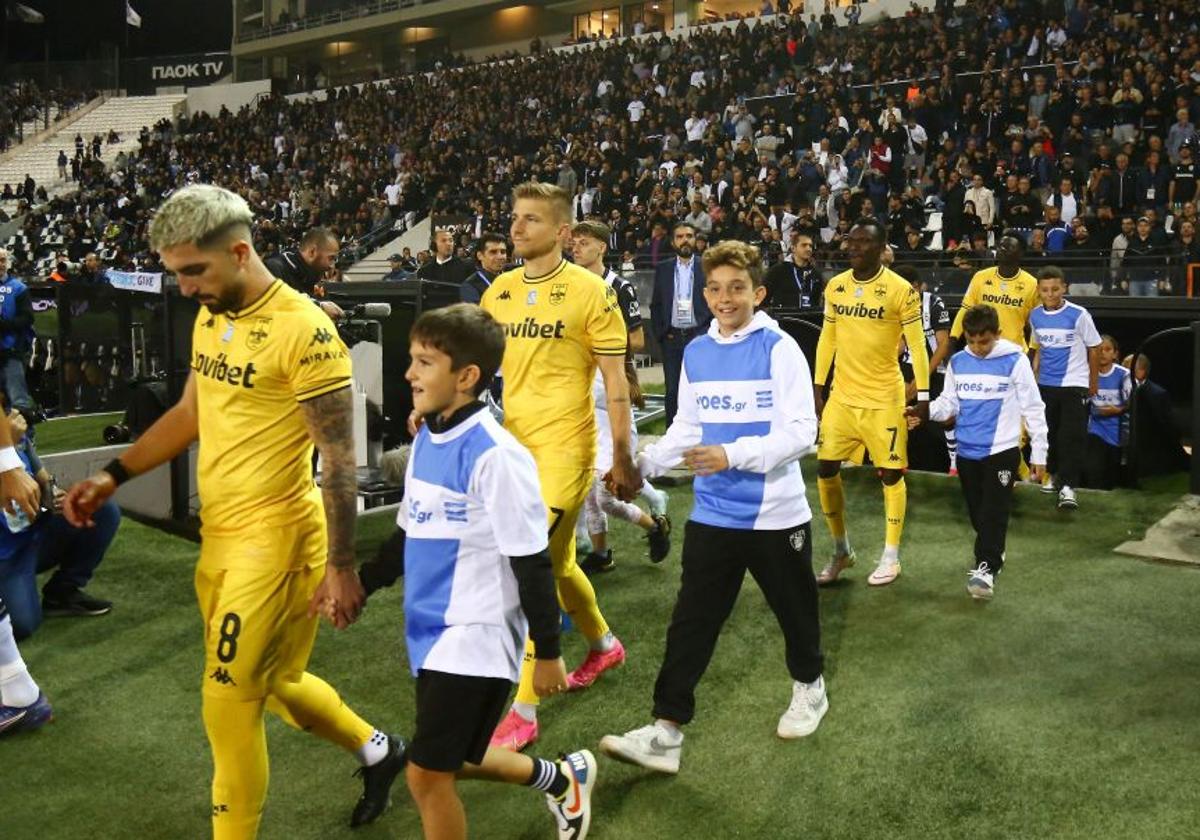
left=650, top=222, right=713, bottom=426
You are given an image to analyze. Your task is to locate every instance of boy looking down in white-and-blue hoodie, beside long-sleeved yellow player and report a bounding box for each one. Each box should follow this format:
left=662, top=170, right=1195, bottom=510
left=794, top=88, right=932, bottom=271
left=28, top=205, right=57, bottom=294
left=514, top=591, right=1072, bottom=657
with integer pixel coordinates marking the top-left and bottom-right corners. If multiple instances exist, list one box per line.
left=905, top=304, right=1046, bottom=600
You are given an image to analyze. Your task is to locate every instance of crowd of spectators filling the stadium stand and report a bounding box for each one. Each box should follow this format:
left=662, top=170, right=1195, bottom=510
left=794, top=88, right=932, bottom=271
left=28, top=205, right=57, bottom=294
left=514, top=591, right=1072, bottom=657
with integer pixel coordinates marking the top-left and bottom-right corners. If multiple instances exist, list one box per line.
left=2, top=0, right=1200, bottom=293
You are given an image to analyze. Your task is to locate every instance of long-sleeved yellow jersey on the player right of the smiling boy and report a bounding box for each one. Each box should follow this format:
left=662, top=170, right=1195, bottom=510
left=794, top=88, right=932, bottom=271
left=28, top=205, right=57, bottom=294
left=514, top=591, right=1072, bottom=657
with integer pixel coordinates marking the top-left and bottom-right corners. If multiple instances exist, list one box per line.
left=815, top=266, right=929, bottom=408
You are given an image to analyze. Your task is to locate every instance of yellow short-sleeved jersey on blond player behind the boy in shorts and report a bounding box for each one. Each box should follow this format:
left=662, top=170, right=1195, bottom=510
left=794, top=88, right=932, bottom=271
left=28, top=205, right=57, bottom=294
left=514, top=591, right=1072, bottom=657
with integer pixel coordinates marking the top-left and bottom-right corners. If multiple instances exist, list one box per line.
left=481, top=259, right=628, bottom=469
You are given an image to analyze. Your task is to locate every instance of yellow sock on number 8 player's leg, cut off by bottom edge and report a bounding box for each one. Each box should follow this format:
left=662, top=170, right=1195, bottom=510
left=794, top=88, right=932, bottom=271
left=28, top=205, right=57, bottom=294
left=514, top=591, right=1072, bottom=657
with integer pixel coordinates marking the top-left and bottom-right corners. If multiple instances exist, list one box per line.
left=202, top=695, right=269, bottom=840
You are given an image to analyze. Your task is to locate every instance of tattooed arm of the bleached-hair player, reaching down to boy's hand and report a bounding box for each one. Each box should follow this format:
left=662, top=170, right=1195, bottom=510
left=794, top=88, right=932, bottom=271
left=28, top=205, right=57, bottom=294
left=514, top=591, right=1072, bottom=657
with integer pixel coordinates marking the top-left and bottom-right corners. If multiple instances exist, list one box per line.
left=300, top=388, right=365, bottom=630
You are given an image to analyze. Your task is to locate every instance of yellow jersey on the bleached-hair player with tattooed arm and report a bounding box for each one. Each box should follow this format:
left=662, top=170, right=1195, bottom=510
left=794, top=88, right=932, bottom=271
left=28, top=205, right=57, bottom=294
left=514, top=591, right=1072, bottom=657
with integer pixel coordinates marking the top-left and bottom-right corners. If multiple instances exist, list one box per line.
left=192, top=280, right=350, bottom=544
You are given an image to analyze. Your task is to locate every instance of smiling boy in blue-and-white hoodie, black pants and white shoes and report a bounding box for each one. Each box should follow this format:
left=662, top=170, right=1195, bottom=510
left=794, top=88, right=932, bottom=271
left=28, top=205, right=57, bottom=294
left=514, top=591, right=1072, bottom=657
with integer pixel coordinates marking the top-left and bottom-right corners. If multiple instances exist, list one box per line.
left=600, top=241, right=829, bottom=773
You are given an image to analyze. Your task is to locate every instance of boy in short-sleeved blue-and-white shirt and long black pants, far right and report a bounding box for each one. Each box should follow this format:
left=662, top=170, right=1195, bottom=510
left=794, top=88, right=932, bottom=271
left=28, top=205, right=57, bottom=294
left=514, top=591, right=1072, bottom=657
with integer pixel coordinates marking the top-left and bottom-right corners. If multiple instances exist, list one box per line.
left=1030, top=265, right=1100, bottom=510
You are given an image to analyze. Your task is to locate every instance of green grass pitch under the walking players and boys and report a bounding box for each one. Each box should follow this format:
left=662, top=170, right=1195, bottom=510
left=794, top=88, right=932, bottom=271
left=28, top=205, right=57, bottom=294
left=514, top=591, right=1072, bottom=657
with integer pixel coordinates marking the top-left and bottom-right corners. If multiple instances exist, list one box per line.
left=0, top=469, right=1200, bottom=840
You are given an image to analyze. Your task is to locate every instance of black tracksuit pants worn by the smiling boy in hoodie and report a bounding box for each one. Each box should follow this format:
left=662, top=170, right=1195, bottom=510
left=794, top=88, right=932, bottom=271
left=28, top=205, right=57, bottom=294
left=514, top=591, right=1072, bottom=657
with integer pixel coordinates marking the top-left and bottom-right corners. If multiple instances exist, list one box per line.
left=654, top=521, right=822, bottom=724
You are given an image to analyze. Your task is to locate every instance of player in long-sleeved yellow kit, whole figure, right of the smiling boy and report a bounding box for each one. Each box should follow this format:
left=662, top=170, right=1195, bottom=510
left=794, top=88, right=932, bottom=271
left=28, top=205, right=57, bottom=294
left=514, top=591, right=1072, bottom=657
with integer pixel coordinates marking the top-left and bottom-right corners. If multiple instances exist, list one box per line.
left=812, top=218, right=929, bottom=586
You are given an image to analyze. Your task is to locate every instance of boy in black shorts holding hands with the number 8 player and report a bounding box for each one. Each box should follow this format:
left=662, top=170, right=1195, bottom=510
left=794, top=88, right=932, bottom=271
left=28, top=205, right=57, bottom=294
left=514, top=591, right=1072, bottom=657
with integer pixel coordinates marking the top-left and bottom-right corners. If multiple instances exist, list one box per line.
left=397, top=304, right=596, bottom=840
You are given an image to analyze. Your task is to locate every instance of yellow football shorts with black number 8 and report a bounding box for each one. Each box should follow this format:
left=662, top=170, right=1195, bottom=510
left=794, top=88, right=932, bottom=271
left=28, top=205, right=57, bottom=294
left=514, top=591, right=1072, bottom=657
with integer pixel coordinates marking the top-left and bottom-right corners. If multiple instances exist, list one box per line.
left=196, top=523, right=326, bottom=701
